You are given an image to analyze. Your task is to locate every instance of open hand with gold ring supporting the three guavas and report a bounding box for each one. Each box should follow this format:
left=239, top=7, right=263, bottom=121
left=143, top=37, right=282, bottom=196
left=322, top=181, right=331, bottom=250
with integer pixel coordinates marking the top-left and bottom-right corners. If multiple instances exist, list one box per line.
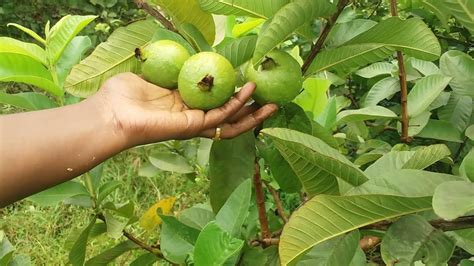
left=93, top=73, right=277, bottom=146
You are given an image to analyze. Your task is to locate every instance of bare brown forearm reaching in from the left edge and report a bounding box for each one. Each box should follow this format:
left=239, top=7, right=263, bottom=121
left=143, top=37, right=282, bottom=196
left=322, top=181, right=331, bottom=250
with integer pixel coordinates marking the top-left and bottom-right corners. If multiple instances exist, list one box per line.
left=0, top=98, right=127, bottom=207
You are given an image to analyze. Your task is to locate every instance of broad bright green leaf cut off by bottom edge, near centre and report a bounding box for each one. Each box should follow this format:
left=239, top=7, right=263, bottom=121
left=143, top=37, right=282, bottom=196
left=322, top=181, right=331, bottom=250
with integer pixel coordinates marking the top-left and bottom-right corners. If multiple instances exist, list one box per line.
left=194, top=222, right=244, bottom=266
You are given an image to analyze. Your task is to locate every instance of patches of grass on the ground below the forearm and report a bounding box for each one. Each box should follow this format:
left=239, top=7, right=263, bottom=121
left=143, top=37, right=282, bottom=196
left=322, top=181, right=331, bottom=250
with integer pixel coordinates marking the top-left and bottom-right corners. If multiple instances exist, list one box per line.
left=0, top=147, right=209, bottom=265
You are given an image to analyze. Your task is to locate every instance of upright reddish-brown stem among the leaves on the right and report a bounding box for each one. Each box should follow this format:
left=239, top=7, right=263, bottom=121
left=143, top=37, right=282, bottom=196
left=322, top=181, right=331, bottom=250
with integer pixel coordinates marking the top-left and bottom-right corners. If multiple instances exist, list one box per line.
left=390, top=0, right=411, bottom=143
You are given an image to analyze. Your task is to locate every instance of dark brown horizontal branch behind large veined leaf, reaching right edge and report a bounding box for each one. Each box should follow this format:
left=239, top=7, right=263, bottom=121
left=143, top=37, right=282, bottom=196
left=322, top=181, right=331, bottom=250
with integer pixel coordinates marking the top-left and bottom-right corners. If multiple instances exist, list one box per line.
left=362, top=215, right=474, bottom=231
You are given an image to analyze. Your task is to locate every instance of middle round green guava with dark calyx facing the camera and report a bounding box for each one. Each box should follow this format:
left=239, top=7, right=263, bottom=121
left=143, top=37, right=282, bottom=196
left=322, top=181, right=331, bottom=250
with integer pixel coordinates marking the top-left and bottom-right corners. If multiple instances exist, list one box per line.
left=178, top=52, right=236, bottom=110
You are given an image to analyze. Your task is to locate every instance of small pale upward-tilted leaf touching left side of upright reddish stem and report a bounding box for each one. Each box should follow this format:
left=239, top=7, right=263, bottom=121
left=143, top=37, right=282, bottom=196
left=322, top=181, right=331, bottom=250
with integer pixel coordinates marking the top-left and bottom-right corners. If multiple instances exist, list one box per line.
left=362, top=77, right=400, bottom=107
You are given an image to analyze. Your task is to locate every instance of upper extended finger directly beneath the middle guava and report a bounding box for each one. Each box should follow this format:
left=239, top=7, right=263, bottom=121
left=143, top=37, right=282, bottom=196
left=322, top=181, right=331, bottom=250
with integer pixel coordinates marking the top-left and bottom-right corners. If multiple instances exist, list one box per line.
left=204, top=82, right=255, bottom=128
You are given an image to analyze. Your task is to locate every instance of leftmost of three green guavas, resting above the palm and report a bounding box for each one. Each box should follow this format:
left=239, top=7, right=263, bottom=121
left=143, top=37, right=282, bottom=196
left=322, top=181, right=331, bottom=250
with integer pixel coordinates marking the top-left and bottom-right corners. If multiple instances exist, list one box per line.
left=140, top=40, right=190, bottom=89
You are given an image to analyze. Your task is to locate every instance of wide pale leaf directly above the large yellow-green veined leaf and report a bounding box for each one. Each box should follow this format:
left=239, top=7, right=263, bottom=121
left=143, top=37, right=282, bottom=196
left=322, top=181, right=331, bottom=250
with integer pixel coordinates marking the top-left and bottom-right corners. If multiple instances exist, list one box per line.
left=347, top=169, right=463, bottom=197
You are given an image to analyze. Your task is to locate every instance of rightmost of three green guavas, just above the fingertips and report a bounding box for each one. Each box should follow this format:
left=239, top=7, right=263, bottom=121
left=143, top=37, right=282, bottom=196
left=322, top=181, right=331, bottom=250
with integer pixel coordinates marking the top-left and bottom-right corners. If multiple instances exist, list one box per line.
left=245, top=50, right=303, bottom=105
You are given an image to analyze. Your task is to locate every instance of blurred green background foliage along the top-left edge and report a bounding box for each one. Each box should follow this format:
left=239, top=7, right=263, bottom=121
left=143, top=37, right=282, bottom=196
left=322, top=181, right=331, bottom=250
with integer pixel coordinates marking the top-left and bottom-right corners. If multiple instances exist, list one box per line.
left=0, top=0, right=146, bottom=46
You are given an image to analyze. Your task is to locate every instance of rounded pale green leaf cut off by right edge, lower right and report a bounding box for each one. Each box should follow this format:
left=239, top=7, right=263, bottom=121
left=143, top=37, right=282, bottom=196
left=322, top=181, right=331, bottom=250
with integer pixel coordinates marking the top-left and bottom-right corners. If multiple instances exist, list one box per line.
left=433, top=181, right=474, bottom=220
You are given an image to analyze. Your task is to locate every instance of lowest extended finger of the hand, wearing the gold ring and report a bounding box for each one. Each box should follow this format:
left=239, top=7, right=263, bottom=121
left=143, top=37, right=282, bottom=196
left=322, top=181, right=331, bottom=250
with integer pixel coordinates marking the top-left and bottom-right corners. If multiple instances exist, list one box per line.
left=202, top=104, right=278, bottom=139
